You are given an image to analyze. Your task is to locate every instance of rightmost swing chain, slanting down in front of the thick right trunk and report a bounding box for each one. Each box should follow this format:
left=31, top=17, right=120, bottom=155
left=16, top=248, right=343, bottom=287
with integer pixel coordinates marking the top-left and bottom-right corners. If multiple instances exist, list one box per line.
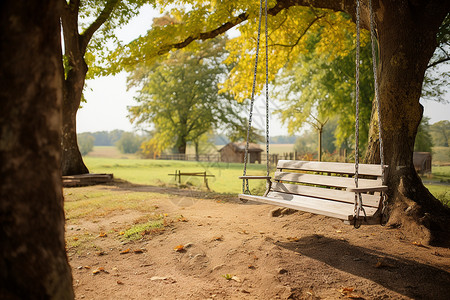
left=369, top=0, right=387, bottom=224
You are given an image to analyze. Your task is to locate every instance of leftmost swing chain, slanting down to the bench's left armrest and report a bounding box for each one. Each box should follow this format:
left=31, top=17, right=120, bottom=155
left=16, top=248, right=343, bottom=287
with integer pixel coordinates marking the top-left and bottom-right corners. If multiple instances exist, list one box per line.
left=242, top=0, right=267, bottom=194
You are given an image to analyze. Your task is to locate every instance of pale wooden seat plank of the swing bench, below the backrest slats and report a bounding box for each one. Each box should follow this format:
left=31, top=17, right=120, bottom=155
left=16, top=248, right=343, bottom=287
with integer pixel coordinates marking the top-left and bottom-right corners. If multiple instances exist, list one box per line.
left=239, top=192, right=377, bottom=221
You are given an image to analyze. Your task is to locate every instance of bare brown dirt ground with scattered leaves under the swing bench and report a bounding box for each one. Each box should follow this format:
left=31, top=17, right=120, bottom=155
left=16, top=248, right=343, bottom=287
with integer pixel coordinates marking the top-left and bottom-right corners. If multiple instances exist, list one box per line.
left=66, top=183, right=450, bottom=299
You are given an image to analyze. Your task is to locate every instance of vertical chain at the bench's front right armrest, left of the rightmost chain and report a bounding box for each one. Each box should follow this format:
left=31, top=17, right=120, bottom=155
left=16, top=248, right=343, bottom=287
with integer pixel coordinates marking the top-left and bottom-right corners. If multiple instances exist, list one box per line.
left=353, top=0, right=362, bottom=228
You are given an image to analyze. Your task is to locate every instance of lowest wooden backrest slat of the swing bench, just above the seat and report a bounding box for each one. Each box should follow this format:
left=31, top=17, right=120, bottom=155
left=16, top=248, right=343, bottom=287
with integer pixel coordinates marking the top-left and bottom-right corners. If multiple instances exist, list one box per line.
left=268, top=182, right=380, bottom=208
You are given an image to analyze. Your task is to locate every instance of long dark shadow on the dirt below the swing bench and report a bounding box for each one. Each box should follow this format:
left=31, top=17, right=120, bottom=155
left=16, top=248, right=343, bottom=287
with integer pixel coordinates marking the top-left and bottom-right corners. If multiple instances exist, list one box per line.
left=276, top=235, right=450, bottom=300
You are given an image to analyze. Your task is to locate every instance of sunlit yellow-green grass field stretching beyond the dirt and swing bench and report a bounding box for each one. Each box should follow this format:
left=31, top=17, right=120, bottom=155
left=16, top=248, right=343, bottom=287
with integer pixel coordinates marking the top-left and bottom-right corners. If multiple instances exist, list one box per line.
left=84, top=145, right=450, bottom=205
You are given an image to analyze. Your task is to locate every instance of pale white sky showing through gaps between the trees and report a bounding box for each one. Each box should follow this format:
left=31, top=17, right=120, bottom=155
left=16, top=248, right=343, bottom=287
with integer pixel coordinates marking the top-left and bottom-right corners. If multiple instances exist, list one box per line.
left=77, top=7, right=450, bottom=136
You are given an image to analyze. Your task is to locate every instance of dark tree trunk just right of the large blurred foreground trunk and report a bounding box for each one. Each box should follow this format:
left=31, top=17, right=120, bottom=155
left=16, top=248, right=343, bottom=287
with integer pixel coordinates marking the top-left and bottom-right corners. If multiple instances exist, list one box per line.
left=61, top=4, right=89, bottom=175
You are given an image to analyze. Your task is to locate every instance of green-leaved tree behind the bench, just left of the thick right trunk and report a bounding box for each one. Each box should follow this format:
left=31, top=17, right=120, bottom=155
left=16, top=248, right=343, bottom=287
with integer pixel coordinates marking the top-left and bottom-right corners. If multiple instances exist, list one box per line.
left=275, top=31, right=374, bottom=149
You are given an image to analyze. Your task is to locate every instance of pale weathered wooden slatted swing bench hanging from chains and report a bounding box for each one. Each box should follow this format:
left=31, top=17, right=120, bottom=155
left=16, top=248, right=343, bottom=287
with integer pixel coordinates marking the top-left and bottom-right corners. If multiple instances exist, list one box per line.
left=239, top=160, right=388, bottom=224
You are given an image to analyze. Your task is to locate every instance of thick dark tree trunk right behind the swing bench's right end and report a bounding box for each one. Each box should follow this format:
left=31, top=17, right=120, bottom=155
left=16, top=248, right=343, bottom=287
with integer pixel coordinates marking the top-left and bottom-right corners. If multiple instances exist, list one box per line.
left=366, top=1, right=450, bottom=243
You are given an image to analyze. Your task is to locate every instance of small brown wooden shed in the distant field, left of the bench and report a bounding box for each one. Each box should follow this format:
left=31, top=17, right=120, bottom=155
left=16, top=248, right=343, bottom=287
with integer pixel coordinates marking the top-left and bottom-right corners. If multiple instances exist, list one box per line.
left=219, top=142, right=263, bottom=164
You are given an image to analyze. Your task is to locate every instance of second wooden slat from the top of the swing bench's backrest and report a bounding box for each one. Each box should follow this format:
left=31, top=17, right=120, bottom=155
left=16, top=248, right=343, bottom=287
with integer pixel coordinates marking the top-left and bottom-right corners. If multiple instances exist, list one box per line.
left=274, top=172, right=381, bottom=188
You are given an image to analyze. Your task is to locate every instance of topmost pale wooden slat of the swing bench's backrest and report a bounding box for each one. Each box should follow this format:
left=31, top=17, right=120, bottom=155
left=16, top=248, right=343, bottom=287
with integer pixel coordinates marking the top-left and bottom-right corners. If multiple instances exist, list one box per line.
left=277, top=160, right=382, bottom=177
